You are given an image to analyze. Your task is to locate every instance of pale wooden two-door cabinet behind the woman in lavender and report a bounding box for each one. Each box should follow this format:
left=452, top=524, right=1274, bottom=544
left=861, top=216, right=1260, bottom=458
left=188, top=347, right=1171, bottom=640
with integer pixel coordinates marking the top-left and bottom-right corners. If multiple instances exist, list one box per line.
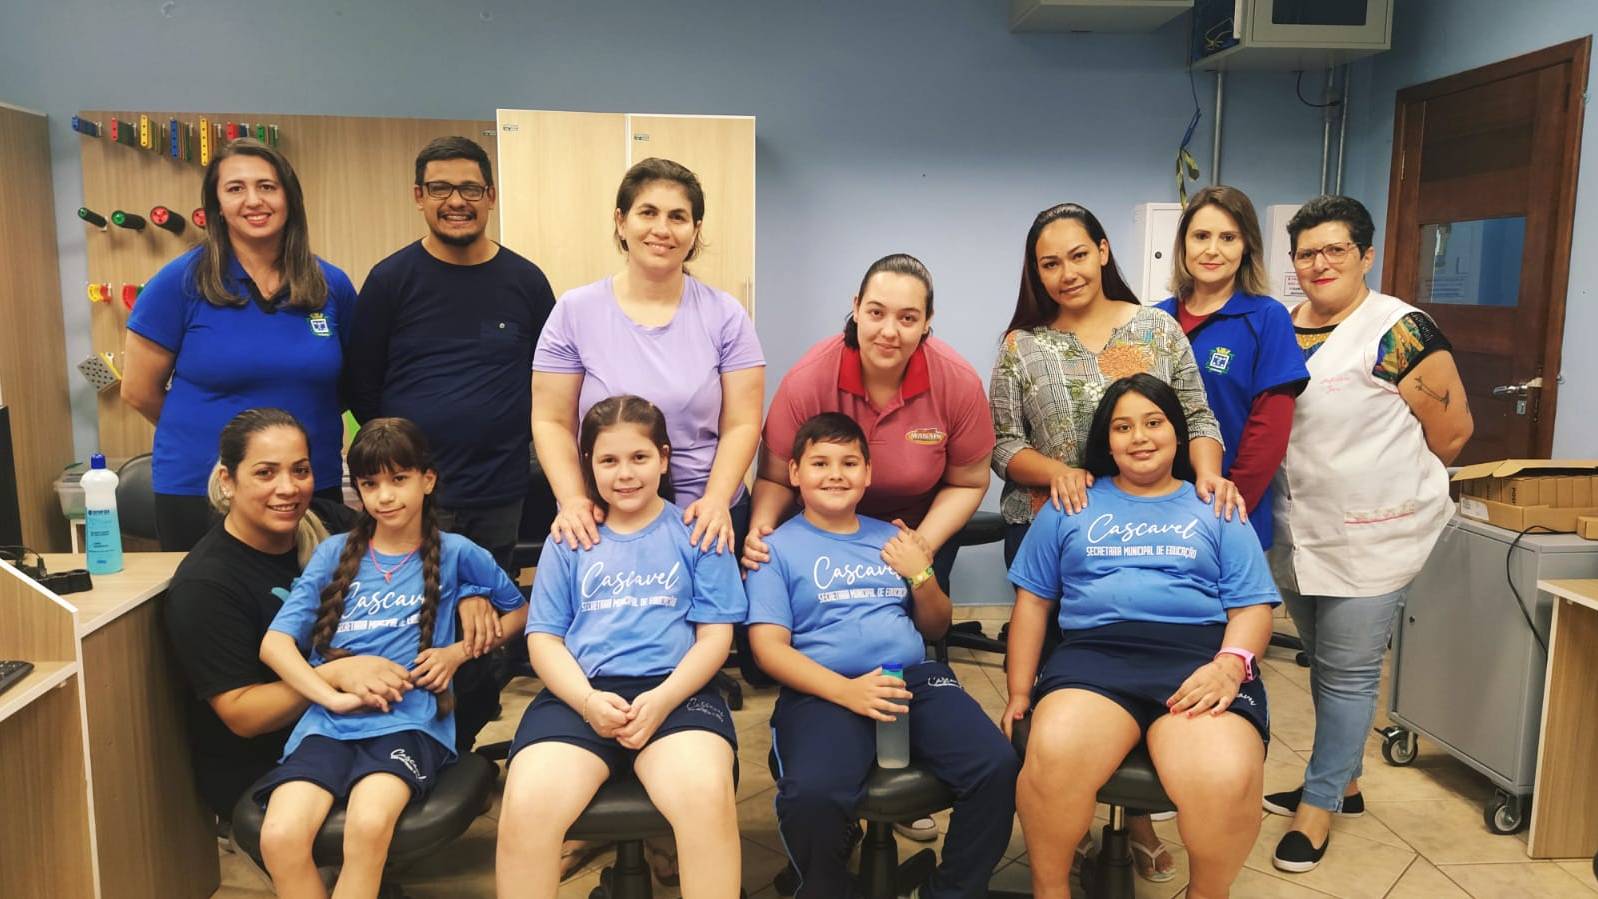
left=499, top=109, right=754, bottom=316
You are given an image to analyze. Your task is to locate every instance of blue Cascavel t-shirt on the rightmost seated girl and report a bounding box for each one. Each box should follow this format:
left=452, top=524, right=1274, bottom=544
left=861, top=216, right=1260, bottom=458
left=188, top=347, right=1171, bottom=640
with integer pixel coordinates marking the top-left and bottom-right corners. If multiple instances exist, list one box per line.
left=1010, top=477, right=1282, bottom=631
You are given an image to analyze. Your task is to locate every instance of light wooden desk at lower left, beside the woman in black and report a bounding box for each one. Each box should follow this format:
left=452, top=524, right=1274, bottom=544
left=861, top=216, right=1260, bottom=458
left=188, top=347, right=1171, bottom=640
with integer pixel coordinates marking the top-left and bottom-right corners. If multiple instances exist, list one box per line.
left=0, top=552, right=221, bottom=899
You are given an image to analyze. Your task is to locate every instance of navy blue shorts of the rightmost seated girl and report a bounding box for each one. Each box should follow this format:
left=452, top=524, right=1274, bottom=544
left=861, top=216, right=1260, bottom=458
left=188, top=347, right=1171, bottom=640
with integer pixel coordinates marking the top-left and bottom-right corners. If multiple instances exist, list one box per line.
left=1032, top=621, right=1270, bottom=744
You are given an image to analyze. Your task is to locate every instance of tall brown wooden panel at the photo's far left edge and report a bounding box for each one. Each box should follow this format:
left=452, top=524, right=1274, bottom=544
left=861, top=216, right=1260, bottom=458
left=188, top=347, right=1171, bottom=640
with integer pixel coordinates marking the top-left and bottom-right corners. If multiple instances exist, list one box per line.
left=0, top=104, right=74, bottom=551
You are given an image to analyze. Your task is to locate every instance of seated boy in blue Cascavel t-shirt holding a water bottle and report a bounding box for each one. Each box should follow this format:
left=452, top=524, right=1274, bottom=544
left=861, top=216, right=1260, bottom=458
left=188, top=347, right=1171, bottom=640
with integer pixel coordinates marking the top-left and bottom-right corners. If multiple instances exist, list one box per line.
left=745, top=412, right=1020, bottom=899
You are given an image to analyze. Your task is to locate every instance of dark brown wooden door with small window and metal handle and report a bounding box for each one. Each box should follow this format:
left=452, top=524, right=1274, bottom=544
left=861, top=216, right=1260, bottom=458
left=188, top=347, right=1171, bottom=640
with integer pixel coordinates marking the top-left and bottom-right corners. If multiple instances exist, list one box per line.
left=1382, top=37, right=1592, bottom=465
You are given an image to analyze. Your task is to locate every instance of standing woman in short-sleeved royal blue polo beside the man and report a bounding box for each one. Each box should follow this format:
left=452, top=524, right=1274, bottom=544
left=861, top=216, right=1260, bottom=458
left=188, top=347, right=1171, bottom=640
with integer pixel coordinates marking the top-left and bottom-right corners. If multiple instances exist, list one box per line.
left=121, top=137, right=355, bottom=552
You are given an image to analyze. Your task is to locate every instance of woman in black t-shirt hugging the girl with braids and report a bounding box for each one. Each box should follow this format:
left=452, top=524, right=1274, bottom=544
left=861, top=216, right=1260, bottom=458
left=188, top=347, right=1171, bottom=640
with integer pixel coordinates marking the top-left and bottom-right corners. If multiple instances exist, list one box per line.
left=166, top=409, right=411, bottom=819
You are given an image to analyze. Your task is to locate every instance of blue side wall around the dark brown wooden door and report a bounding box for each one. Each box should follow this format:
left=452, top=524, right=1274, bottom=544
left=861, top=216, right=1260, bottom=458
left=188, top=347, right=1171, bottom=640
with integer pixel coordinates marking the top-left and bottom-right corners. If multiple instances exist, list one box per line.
left=1342, top=0, right=1598, bottom=458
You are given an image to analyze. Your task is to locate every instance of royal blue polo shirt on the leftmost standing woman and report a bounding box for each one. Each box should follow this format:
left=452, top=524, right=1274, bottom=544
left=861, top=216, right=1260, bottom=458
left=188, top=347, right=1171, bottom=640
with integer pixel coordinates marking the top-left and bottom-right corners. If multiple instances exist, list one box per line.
left=128, top=246, right=355, bottom=497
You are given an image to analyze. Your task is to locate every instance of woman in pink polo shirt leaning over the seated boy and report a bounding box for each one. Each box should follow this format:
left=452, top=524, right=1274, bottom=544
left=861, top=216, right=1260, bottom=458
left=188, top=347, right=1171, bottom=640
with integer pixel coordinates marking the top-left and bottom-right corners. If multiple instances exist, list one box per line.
left=743, top=254, right=994, bottom=589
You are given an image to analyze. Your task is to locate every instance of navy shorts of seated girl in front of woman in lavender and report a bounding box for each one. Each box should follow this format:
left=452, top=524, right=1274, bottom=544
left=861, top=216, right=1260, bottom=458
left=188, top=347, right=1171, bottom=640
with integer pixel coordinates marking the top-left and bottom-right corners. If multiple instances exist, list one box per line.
left=510, top=674, right=738, bottom=776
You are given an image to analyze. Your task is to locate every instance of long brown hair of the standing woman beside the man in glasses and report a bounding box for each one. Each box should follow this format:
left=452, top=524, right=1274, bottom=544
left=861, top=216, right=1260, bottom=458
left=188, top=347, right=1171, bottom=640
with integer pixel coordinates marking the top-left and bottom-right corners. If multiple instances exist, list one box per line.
left=193, top=137, right=328, bottom=311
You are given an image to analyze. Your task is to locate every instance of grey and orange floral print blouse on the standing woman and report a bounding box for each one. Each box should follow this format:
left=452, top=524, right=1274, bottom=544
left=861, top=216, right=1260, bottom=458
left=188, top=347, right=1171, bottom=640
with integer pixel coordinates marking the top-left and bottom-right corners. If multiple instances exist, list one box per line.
left=988, top=307, right=1221, bottom=524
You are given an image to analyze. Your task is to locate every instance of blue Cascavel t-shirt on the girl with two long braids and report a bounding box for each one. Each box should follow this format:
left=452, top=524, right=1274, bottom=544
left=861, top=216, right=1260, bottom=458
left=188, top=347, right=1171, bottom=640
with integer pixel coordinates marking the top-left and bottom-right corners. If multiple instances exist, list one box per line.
left=272, top=533, right=524, bottom=758
